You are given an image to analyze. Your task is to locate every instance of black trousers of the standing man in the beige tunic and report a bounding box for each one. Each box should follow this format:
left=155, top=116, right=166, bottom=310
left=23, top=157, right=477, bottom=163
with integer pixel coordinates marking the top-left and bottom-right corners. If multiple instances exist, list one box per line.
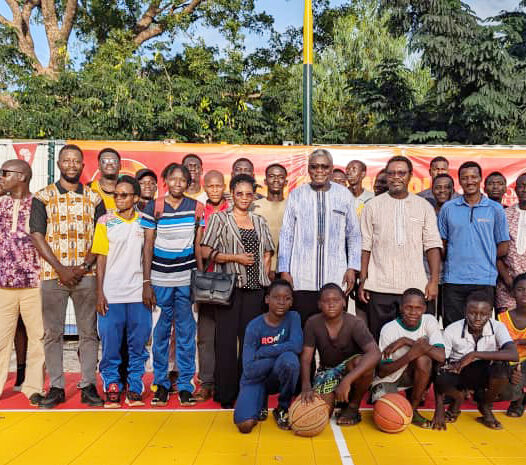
left=367, top=291, right=435, bottom=342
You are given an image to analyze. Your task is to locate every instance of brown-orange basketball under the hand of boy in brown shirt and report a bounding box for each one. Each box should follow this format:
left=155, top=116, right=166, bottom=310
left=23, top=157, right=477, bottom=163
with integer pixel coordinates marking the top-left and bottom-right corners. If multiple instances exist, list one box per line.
left=289, top=396, right=329, bottom=438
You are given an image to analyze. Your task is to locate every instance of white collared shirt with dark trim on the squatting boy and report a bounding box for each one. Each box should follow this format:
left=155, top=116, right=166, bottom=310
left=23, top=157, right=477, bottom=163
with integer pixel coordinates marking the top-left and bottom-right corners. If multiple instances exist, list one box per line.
left=444, top=319, right=512, bottom=362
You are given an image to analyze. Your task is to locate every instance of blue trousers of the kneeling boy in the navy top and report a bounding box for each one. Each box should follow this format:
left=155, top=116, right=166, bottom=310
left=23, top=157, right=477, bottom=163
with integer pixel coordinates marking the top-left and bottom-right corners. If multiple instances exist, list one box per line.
left=234, top=352, right=300, bottom=424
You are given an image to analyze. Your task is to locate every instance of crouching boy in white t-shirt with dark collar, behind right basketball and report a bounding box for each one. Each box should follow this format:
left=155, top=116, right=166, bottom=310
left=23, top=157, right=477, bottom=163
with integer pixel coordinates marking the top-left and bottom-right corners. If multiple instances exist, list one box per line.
left=371, top=288, right=446, bottom=429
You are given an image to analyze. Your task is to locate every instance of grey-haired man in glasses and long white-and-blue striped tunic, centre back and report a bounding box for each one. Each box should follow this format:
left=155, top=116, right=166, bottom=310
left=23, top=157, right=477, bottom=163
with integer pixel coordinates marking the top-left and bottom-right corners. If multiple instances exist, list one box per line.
left=277, top=149, right=361, bottom=326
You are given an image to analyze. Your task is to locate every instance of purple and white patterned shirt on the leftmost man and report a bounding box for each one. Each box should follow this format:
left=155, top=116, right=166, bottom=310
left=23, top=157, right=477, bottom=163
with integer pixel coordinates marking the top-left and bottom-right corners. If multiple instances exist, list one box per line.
left=0, top=195, right=40, bottom=289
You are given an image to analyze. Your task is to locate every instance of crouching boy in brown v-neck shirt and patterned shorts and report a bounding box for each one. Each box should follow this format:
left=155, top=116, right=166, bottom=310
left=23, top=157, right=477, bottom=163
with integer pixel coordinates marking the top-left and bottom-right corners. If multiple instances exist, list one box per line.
left=301, top=283, right=381, bottom=425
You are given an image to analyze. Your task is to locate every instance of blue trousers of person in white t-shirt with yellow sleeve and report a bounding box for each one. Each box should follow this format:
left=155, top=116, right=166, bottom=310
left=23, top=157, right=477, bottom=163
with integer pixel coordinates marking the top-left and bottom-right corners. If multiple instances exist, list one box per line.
left=97, top=302, right=152, bottom=394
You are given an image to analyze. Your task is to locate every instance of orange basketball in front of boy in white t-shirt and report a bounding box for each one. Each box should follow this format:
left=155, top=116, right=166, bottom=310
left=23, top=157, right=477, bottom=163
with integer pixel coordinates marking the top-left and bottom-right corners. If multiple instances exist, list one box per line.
left=373, top=394, right=413, bottom=433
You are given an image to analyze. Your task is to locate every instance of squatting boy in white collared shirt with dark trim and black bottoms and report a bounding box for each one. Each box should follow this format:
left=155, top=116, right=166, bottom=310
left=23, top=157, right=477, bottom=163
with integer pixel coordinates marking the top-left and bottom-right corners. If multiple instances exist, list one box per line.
left=433, top=292, right=519, bottom=429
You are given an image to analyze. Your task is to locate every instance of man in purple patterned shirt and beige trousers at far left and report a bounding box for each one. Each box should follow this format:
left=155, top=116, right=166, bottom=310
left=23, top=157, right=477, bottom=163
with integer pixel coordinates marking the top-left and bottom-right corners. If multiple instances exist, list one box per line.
left=0, top=160, right=44, bottom=405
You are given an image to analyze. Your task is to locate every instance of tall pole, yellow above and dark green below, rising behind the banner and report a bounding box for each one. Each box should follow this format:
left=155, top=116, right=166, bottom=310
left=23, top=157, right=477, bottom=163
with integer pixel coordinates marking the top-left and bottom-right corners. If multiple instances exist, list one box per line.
left=303, top=0, right=313, bottom=145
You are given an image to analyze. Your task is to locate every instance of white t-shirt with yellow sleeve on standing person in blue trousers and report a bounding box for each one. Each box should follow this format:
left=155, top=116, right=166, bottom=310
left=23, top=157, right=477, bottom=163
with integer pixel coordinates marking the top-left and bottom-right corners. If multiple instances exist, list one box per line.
left=91, top=213, right=144, bottom=304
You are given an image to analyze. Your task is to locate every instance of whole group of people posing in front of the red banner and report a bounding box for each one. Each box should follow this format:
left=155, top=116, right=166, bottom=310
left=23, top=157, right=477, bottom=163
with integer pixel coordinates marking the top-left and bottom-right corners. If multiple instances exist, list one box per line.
left=0, top=144, right=526, bottom=433
